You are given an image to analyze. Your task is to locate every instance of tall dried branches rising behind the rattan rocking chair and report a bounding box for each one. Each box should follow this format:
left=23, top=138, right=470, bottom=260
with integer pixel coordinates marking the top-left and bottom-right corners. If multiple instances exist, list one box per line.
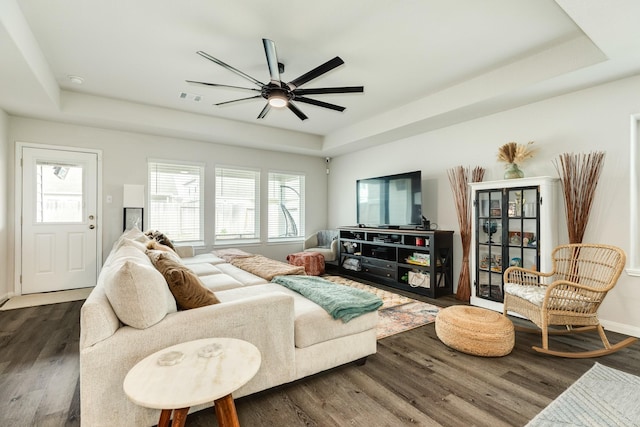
left=553, top=151, right=605, bottom=243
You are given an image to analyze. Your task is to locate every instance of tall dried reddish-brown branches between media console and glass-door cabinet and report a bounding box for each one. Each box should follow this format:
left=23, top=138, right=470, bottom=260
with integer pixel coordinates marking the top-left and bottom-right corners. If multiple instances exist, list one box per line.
left=447, top=166, right=485, bottom=301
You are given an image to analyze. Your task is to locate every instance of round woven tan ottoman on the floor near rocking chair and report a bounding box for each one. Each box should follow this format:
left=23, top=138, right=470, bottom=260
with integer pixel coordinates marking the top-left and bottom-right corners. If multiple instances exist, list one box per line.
left=436, top=305, right=515, bottom=357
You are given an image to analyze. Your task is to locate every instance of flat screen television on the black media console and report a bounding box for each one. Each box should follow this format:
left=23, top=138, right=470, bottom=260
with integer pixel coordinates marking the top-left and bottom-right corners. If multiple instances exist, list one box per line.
left=356, top=171, right=422, bottom=228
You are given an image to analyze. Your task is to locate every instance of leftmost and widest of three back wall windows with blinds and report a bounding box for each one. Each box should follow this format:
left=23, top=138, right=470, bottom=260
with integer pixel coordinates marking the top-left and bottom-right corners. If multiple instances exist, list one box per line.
left=148, top=160, right=204, bottom=242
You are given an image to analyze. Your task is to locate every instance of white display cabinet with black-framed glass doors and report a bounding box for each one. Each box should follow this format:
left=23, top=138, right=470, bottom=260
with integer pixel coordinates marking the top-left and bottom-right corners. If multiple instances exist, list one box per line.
left=469, top=177, right=559, bottom=311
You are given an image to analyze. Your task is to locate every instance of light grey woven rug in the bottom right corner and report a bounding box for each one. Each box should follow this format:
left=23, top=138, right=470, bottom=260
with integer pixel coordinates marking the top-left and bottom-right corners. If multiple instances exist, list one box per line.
left=527, top=363, right=640, bottom=427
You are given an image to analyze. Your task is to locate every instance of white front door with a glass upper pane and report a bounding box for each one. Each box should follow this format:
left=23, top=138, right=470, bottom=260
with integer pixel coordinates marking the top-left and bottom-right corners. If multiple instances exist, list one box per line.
left=21, top=147, right=98, bottom=294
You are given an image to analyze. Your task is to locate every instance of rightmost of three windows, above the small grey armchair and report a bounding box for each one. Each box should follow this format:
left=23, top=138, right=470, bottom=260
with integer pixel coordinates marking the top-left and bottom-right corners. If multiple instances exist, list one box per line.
left=268, top=172, right=305, bottom=241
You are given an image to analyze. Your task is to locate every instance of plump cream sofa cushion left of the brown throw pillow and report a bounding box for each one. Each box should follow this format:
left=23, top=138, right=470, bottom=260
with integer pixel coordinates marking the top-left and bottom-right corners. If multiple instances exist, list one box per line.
left=101, top=257, right=176, bottom=329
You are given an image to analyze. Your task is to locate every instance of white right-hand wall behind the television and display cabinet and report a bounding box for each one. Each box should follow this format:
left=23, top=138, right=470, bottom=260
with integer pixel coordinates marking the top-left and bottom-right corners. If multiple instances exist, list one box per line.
left=328, top=77, right=640, bottom=336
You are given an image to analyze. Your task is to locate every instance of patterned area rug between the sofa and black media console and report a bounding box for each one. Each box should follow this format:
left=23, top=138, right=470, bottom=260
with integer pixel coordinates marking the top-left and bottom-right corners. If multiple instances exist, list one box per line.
left=323, top=276, right=440, bottom=339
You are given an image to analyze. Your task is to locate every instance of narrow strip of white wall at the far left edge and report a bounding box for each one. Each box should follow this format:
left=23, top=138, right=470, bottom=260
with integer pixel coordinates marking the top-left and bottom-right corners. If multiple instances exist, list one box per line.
left=0, top=110, right=8, bottom=302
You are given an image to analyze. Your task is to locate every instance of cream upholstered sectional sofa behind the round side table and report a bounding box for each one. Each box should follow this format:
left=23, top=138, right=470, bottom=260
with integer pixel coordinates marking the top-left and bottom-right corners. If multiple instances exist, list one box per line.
left=80, top=231, right=378, bottom=427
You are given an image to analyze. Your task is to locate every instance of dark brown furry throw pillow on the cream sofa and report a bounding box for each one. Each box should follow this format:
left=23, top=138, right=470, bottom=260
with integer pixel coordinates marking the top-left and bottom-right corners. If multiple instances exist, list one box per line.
left=152, top=254, right=220, bottom=310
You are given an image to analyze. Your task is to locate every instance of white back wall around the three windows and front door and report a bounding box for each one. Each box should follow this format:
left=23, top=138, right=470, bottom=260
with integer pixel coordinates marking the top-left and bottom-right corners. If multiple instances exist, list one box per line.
left=7, top=117, right=327, bottom=287
